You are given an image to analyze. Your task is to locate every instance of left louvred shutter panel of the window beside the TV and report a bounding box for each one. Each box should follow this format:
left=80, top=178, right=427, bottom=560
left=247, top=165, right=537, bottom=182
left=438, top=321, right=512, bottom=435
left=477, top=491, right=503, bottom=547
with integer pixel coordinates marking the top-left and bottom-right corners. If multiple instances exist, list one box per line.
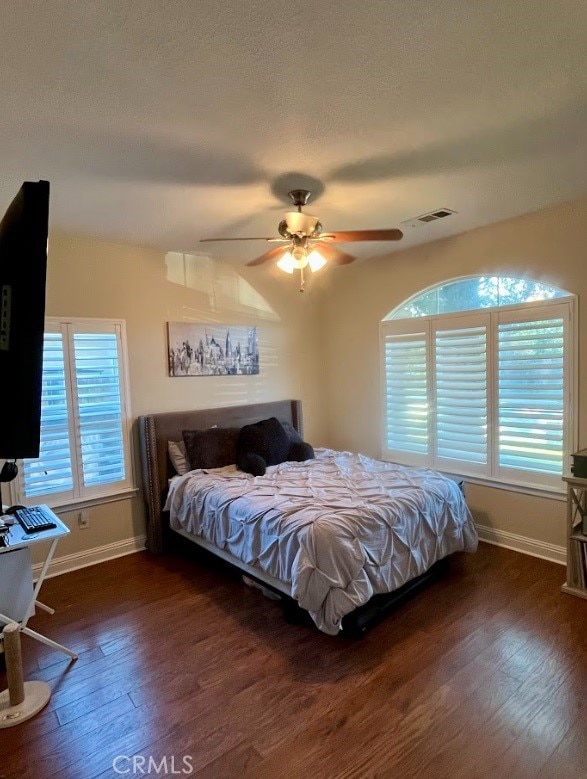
left=22, top=332, right=73, bottom=497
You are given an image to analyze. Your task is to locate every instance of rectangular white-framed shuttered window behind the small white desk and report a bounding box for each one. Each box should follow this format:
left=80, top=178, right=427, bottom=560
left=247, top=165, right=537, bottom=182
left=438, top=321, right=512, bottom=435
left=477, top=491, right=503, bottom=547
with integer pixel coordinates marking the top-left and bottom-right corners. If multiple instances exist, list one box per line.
left=17, top=318, right=132, bottom=506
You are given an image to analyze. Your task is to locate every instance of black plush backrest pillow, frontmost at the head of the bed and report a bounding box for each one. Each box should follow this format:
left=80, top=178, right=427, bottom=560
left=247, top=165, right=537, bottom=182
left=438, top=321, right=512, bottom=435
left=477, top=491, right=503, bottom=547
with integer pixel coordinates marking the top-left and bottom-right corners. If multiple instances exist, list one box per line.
left=236, top=417, right=290, bottom=476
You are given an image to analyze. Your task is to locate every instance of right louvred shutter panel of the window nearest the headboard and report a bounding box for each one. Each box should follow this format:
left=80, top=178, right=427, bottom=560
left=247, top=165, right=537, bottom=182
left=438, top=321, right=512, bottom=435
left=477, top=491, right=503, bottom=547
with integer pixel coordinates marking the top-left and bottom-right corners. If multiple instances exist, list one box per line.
left=73, top=332, right=125, bottom=487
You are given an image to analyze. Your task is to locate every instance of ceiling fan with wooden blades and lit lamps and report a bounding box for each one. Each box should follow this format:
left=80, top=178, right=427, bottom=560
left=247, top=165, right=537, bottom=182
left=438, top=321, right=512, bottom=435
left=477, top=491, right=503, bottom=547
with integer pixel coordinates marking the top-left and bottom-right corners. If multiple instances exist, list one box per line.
left=201, top=189, right=403, bottom=292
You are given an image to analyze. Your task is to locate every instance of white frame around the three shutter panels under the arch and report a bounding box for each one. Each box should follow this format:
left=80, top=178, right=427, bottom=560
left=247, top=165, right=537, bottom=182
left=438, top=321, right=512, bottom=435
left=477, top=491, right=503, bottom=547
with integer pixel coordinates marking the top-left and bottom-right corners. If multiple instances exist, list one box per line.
left=380, top=295, right=578, bottom=496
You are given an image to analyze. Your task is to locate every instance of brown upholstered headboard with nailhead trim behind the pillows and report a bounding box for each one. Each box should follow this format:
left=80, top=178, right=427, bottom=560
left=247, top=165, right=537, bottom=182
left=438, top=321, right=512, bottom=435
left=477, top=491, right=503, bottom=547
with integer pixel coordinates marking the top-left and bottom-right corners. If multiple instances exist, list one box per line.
left=138, top=400, right=304, bottom=554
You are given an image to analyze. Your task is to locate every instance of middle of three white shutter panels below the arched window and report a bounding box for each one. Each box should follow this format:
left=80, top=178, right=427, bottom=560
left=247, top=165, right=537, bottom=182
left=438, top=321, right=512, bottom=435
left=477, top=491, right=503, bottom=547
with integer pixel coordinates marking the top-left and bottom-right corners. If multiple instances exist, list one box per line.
left=434, top=315, right=488, bottom=474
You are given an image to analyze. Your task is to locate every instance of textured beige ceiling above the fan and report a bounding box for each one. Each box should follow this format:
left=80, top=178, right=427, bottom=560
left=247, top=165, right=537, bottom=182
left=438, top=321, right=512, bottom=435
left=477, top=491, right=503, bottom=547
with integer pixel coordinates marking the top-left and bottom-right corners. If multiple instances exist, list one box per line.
left=0, top=0, right=587, bottom=261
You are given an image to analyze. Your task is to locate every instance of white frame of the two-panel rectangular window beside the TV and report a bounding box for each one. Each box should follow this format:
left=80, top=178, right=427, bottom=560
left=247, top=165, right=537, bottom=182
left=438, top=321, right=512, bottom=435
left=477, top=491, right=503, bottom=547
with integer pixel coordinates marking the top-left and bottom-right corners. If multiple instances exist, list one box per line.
left=11, top=317, right=137, bottom=509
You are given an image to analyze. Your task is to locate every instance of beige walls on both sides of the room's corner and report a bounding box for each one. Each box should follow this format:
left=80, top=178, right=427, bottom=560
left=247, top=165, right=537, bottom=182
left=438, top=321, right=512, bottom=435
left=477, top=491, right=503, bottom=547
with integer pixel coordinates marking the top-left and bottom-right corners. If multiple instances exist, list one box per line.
left=34, top=195, right=587, bottom=568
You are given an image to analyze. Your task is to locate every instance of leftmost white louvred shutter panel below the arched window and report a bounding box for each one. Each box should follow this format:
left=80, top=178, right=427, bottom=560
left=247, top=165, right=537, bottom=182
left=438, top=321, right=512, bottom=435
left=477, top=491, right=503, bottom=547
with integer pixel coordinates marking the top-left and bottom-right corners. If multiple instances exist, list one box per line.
left=383, top=323, right=430, bottom=463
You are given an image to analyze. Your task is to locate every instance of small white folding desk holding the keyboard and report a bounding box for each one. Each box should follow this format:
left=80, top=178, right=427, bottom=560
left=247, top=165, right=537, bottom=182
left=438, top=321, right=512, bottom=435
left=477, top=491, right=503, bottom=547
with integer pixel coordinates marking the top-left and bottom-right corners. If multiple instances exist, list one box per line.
left=0, top=506, right=77, bottom=660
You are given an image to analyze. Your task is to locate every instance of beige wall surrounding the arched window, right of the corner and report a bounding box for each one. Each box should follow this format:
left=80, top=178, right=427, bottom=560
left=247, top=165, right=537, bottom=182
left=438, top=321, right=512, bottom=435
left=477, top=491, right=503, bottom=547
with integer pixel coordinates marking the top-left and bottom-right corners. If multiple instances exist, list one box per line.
left=323, top=199, right=587, bottom=546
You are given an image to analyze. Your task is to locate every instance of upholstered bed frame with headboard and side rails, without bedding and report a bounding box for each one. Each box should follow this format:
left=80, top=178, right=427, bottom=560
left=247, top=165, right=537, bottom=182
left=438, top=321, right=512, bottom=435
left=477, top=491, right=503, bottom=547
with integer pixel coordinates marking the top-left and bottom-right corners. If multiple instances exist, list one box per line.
left=138, top=400, right=444, bottom=636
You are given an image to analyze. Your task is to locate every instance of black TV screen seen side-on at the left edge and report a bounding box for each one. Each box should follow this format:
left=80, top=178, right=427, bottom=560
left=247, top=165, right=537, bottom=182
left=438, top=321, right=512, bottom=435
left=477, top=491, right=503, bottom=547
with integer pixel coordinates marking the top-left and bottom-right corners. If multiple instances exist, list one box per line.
left=0, top=181, right=49, bottom=459
